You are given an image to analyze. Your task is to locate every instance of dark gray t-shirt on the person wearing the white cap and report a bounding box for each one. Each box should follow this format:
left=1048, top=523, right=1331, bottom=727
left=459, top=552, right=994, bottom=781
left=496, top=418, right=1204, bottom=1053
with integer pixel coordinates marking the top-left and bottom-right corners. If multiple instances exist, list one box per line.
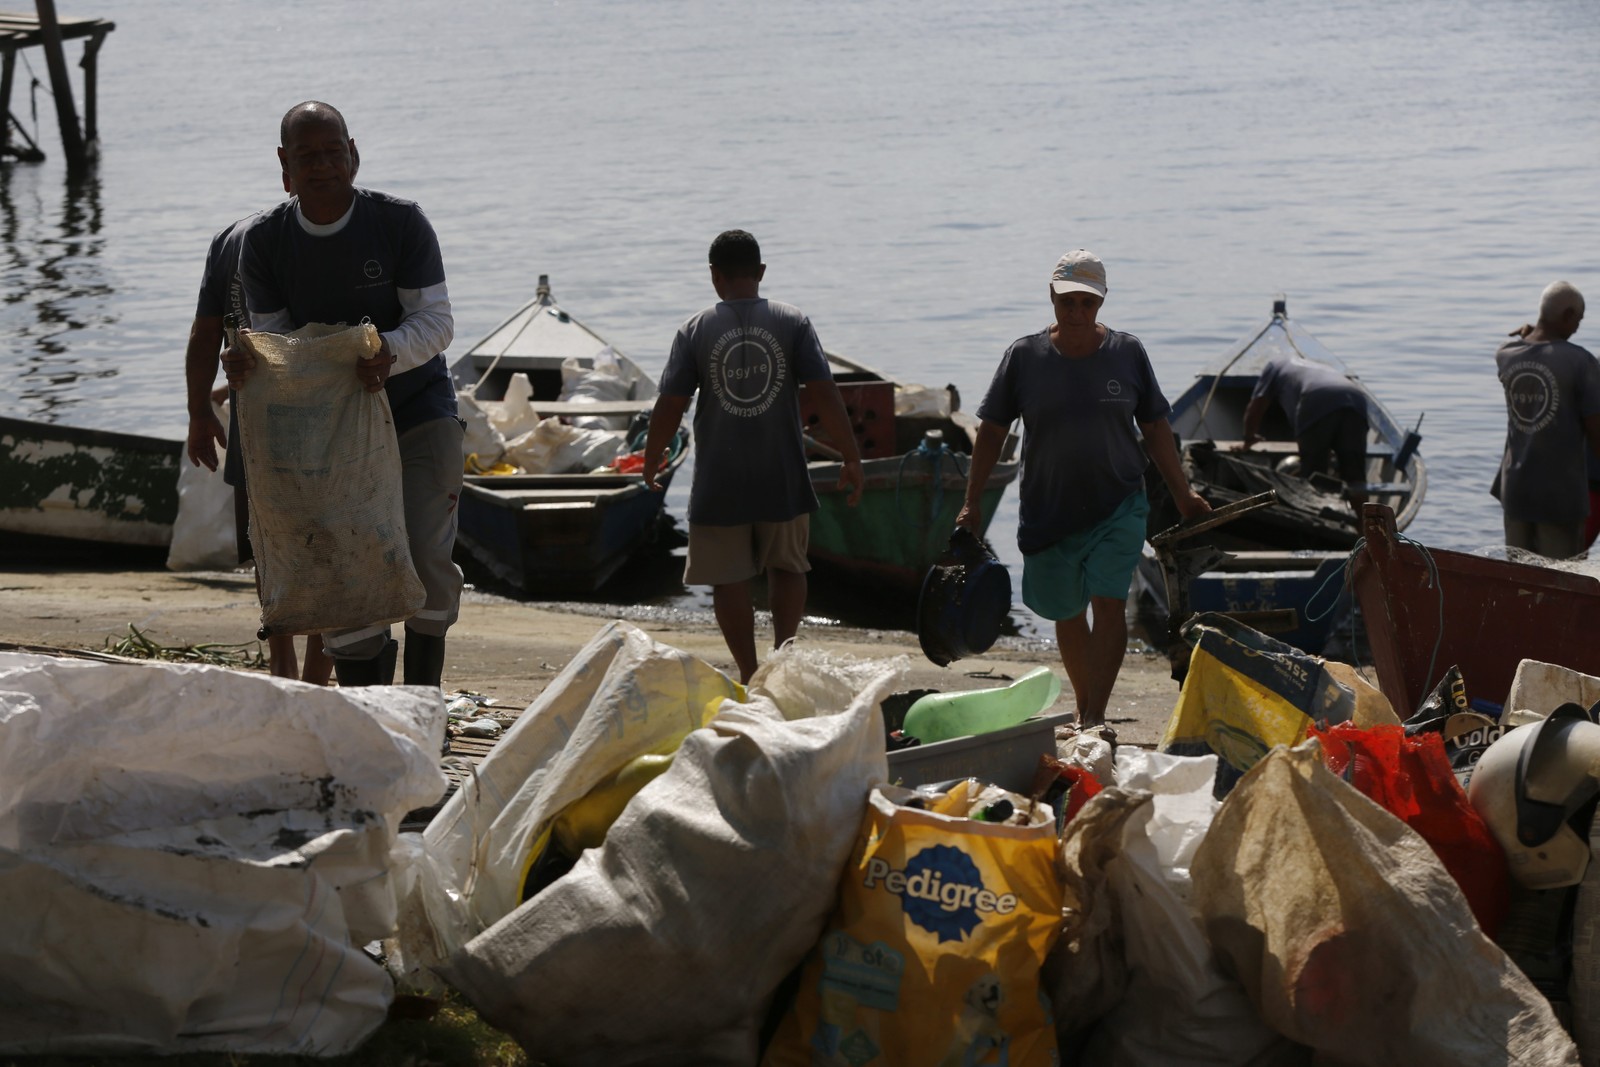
left=978, top=328, right=1171, bottom=553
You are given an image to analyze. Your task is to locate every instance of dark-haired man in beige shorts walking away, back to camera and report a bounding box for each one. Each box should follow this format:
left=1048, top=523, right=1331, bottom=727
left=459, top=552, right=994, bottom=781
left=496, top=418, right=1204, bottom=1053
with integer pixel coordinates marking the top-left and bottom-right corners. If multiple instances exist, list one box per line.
left=645, top=230, right=861, bottom=681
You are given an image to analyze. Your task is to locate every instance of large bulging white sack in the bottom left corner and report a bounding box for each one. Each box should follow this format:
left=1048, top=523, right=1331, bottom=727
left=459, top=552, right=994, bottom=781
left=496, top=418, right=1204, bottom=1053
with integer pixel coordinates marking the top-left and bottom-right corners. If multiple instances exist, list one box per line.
left=0, top=653, right=445, bottom=1056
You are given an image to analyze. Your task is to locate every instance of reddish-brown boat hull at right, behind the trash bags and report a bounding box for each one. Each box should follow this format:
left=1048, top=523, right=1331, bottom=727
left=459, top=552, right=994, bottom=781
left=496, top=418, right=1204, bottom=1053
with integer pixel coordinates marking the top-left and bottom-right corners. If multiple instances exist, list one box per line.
left=1352, top=504, right=1600, bottom=717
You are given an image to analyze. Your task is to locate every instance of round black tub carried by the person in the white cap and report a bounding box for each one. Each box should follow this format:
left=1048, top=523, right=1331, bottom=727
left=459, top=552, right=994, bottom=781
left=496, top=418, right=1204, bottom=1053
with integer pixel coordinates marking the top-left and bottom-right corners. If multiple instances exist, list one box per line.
left=917, top=526, right=1011, bottom=667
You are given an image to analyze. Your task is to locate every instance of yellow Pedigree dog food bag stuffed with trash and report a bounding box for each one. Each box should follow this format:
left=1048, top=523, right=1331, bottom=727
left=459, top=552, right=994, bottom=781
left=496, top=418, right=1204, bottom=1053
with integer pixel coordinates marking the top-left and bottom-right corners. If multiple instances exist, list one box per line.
left=762, top=781, right=1062, bottom=1067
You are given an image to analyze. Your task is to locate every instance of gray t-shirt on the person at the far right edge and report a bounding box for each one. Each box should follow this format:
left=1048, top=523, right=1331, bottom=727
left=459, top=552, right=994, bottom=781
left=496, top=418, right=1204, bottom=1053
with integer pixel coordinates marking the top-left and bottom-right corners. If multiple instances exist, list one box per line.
left=1491, top=339, right=1600, bottom=523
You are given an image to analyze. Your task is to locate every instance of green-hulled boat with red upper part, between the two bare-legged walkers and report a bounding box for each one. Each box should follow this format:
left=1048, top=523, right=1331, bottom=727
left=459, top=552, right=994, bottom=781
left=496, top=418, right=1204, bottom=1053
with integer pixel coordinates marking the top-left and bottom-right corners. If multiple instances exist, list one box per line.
left=800, top=352, right=1019, bottom=592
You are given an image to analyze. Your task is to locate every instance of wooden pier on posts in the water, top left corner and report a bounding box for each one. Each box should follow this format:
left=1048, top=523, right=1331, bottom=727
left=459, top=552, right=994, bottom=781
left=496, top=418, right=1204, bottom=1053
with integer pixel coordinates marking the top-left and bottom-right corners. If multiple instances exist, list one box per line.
left=0, top=0, right=117, bottom=173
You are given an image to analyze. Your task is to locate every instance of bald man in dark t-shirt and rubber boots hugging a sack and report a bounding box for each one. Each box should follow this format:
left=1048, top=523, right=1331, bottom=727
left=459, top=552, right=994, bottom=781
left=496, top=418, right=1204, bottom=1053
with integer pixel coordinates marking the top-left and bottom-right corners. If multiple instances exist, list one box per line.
left=222, top=101, right=462, bottom=686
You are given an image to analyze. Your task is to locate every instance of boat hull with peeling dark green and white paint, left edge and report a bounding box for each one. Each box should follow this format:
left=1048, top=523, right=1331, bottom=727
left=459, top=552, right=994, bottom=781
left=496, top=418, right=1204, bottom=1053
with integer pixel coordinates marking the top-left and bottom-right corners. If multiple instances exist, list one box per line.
left=0, top=418, right=182, bottom=558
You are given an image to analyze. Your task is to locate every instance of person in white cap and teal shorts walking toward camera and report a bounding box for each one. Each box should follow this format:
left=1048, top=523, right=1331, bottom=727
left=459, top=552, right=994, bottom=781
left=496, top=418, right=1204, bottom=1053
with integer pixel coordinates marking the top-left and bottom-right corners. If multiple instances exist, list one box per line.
left=955, top=248, right=1211, bottom=726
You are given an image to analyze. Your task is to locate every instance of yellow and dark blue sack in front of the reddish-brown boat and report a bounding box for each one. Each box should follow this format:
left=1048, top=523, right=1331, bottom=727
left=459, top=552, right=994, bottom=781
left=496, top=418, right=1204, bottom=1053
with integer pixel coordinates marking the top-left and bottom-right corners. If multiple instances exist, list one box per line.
left=1158, top=613, right=1357, bottom=797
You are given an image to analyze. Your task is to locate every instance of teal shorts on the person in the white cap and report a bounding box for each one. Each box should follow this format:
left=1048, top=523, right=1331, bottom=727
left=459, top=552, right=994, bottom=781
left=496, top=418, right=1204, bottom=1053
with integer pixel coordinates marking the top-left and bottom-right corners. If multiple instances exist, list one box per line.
left=1022, top=490, right=1150, bottom=621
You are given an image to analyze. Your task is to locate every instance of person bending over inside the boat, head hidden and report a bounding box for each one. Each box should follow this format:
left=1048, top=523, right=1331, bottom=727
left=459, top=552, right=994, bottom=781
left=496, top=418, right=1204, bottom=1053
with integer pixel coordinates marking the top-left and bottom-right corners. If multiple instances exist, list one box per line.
left=1245, top=355, right=1368, bottom=515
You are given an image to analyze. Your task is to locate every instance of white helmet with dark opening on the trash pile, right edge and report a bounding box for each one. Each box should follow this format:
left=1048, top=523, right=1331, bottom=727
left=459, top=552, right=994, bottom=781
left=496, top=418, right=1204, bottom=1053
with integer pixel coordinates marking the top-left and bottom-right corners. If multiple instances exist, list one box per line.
left=1467, top=704, right=1600, bottom=889
